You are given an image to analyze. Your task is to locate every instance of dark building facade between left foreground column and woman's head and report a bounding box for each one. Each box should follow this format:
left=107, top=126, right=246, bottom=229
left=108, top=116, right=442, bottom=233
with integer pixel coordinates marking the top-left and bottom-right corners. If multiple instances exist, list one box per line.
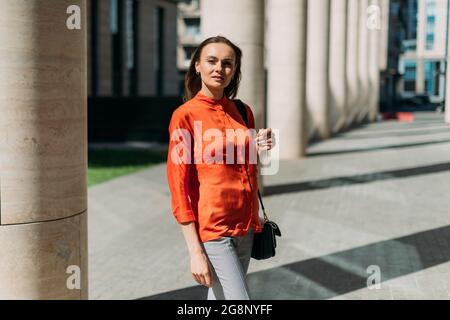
left=87, top=0, right=178, bottom=96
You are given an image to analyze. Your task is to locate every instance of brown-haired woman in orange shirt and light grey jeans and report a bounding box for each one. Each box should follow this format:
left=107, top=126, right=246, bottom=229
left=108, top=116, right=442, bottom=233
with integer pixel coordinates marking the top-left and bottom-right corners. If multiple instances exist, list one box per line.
left=167, top=36, right=272, bottom=300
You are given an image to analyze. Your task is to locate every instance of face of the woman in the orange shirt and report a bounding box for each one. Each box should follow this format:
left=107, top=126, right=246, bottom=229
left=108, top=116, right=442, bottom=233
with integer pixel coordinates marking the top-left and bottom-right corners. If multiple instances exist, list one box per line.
left=195, top=43, right=236, bottom=90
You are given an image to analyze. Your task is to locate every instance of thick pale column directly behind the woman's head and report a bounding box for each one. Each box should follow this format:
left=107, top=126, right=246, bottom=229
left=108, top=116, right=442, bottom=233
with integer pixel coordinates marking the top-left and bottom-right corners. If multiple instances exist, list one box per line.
left=201, top=0, right=265, bottom=128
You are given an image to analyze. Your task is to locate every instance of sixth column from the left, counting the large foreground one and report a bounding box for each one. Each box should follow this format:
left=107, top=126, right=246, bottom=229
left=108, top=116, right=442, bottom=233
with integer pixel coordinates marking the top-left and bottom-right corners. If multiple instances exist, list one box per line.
left=346, top=0, right=360, bottom=126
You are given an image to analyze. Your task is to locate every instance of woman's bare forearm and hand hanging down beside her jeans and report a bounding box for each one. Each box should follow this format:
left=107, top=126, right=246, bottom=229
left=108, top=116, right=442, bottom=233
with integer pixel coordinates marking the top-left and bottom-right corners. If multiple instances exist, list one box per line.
left=181, top=222, right=212, bottom=288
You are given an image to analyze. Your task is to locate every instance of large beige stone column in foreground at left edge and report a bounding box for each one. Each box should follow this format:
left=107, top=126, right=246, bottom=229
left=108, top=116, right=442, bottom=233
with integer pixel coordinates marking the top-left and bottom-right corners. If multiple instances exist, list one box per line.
left=0, top=0, right=88, bottom=299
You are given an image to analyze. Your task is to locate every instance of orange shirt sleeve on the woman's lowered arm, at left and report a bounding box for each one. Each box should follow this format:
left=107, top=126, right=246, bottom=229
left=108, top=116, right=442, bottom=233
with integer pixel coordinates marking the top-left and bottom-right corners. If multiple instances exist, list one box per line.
left=167, top=111, right=196, bottom=223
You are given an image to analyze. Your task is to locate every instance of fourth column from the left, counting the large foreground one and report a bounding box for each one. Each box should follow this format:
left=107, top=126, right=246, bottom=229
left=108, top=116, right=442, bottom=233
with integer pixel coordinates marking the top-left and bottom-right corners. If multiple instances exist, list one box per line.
left=306, top=0, right=330, bottom=139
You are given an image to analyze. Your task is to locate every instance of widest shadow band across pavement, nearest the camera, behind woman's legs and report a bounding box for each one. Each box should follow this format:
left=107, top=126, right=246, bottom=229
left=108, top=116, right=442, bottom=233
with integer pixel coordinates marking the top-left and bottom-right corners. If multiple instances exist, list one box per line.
left=141, top=226, right=450, bottom=300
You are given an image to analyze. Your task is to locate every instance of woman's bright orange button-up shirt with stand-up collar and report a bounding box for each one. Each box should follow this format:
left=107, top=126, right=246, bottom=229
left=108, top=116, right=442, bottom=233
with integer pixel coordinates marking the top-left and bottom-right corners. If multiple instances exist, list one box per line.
left=167, top=92, right=262, bottom=242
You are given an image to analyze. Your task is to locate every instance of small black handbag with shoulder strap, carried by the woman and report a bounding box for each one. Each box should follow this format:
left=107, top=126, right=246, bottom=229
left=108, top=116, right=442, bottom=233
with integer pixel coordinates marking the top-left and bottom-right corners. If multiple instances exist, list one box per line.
left=234, top=99, right=281, bottom=260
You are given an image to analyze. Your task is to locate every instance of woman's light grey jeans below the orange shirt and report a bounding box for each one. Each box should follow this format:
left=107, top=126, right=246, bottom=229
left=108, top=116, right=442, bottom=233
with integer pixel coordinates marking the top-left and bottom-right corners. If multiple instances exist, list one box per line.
left=203, top=229, right=253, bottom=300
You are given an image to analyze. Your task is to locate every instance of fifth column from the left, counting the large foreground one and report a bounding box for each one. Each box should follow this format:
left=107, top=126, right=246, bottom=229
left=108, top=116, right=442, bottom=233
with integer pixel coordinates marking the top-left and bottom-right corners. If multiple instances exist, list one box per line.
left=330, top=0, right=348, bottom=132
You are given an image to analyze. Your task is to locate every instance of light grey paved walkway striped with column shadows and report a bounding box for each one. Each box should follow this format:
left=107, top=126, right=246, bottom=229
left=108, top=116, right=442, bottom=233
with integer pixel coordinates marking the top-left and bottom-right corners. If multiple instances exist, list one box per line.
left=88, top=113, right=450, bottom=299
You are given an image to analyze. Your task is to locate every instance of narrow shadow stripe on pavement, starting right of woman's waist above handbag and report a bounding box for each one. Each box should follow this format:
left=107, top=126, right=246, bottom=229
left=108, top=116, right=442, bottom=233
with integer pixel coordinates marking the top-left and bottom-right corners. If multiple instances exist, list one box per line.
left=264, top=162, right=450, bottom=196
